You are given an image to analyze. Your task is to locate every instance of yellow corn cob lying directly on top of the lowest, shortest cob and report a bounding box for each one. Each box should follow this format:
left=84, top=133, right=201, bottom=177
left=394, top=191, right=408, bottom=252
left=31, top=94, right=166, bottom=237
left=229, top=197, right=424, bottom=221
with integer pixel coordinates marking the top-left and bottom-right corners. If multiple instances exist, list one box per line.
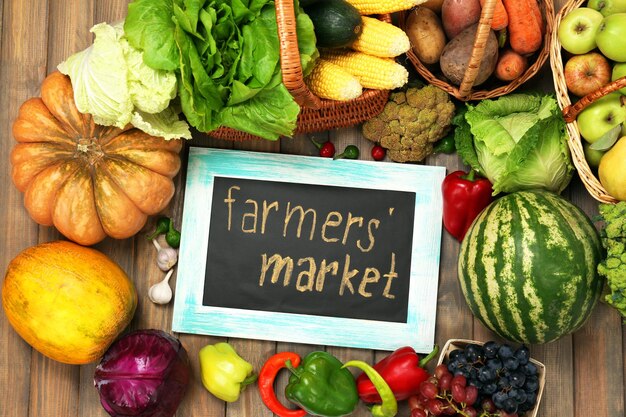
left=322, top=51, right=409, bottom=90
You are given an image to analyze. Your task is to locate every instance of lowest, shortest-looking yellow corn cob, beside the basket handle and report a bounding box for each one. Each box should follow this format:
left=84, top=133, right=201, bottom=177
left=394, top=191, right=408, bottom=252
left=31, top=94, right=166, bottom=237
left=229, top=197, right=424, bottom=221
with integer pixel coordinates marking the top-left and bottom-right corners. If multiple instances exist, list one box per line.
left=305, top=59, right=363, bottom=101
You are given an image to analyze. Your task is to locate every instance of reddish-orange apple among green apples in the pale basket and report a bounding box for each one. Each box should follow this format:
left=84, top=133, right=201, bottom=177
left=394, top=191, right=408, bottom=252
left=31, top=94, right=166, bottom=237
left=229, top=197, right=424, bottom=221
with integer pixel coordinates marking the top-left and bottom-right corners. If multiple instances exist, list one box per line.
left=563, top=52, right=611, bottom=97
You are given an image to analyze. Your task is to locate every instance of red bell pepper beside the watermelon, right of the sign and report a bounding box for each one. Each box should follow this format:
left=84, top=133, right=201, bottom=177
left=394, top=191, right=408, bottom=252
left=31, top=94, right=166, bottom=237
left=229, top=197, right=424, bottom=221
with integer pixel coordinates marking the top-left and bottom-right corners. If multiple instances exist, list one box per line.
left=441, top=170, right=493, bottom=242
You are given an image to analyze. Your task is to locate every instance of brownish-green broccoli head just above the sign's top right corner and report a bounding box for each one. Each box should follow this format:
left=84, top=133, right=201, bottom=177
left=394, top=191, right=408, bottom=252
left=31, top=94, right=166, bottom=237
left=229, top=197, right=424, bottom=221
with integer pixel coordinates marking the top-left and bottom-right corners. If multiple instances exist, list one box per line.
left=363, top=85, right=455, bottom=162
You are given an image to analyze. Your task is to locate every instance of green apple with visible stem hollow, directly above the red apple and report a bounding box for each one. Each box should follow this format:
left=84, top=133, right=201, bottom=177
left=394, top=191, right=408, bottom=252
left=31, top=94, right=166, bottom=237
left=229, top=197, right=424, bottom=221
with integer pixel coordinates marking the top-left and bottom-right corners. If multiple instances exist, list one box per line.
left=557, top=7, right=604, bottom=55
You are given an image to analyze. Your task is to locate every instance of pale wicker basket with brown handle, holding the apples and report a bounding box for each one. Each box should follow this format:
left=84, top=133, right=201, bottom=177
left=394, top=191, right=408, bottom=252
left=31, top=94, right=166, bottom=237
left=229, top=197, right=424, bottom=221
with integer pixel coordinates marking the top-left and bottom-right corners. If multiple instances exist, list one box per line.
left=550, top=0, right=626, bottom=203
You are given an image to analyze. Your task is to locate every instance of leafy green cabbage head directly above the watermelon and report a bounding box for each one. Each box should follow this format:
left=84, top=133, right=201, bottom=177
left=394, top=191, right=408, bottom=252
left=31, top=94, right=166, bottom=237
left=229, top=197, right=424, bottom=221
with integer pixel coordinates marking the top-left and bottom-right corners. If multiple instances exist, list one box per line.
left=455, top=94, right=574, bottom=195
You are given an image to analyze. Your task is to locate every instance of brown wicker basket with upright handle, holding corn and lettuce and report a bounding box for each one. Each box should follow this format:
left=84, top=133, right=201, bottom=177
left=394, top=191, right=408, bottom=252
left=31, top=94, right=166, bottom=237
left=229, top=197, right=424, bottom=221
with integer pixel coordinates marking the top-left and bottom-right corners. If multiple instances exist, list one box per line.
left=208, top=0, right=391, bottom=141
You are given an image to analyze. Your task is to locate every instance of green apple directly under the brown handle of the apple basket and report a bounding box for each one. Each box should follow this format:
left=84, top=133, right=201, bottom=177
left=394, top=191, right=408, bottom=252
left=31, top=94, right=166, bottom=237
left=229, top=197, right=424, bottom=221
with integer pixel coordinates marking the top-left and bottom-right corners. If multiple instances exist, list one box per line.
left=576, top=92, right=626, bottom=143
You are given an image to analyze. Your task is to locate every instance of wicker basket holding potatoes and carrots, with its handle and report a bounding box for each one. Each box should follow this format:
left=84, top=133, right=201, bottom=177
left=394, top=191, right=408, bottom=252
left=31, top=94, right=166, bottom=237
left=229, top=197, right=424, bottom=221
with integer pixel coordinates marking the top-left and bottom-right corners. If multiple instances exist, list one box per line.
left=401, top=0, right=554, bottom=101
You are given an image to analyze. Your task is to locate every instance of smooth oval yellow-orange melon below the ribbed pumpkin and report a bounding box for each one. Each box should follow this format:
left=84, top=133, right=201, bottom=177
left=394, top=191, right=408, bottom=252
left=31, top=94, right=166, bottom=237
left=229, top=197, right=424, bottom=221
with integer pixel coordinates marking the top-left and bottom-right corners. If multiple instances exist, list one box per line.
left=2, top=241, right=137, bottom=364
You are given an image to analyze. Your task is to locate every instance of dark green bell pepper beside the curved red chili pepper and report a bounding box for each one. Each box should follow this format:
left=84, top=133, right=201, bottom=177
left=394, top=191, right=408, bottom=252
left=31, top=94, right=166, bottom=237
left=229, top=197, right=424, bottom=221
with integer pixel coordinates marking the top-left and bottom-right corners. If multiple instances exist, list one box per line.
left=285, top=351, right=359, bottom=417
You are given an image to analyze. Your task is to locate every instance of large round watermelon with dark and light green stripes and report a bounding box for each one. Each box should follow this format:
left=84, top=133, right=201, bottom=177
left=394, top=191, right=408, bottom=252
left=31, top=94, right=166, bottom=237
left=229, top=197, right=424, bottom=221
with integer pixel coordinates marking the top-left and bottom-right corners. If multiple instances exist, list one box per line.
left=458, top=191, right=604, bottom=344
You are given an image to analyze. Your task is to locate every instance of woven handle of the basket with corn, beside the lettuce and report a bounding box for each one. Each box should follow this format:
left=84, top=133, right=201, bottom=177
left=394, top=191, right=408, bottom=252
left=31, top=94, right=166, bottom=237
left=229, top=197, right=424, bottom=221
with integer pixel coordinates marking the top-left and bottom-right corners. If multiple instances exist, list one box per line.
left=274, top=0, right=322, bottom=109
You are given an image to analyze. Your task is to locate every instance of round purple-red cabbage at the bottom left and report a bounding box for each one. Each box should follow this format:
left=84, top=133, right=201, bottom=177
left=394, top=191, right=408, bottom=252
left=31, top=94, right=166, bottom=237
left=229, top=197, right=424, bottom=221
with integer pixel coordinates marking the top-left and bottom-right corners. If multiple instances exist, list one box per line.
left=94, top=330, right=191, bottom=417
